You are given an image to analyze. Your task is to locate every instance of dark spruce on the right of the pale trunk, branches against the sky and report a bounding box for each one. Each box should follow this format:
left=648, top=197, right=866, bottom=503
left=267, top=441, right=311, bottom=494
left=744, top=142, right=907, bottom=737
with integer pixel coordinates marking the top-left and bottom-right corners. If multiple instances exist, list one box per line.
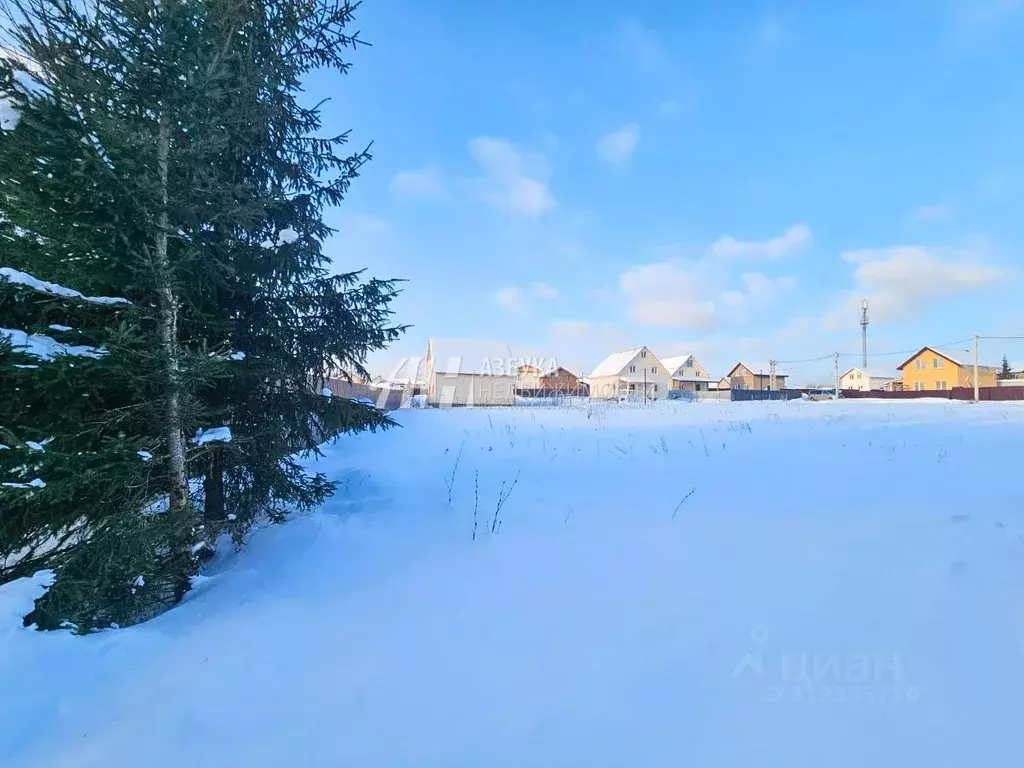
left=155, top=0, right=402, bottom=540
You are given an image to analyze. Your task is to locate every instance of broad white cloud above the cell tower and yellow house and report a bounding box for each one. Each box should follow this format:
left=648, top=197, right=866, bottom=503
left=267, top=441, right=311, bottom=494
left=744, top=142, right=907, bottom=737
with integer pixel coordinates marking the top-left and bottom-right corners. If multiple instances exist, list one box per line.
left=822, top=246, right=1010, bottom=329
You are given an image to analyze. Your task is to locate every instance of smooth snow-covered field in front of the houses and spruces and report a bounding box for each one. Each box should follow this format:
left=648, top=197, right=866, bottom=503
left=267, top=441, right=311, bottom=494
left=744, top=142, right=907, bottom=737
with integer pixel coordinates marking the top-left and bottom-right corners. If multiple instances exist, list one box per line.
left=0, top=400, right=1024, bottom=768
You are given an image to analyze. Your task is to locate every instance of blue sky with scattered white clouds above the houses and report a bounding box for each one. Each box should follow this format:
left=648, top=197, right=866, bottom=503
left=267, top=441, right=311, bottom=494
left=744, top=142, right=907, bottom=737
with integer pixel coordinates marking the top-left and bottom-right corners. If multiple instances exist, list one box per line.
left=308, top=0, right=1024, bottom=381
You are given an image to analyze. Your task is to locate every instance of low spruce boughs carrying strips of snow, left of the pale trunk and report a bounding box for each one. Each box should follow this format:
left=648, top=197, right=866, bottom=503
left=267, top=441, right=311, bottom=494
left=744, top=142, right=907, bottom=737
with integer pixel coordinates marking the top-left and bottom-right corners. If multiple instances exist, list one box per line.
left=0, top=268, right=201, bottom=629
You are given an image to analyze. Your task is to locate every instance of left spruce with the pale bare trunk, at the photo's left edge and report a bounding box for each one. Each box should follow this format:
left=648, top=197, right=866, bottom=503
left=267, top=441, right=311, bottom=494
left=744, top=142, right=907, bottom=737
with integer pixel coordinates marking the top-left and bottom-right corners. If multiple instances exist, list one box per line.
left=0, top=0, right=228, bottom=629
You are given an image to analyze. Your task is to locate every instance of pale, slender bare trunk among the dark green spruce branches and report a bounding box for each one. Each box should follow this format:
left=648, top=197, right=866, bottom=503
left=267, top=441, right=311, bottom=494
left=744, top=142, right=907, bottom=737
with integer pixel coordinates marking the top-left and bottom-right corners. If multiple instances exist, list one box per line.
left=157, top=115, right=188, bottom=516
